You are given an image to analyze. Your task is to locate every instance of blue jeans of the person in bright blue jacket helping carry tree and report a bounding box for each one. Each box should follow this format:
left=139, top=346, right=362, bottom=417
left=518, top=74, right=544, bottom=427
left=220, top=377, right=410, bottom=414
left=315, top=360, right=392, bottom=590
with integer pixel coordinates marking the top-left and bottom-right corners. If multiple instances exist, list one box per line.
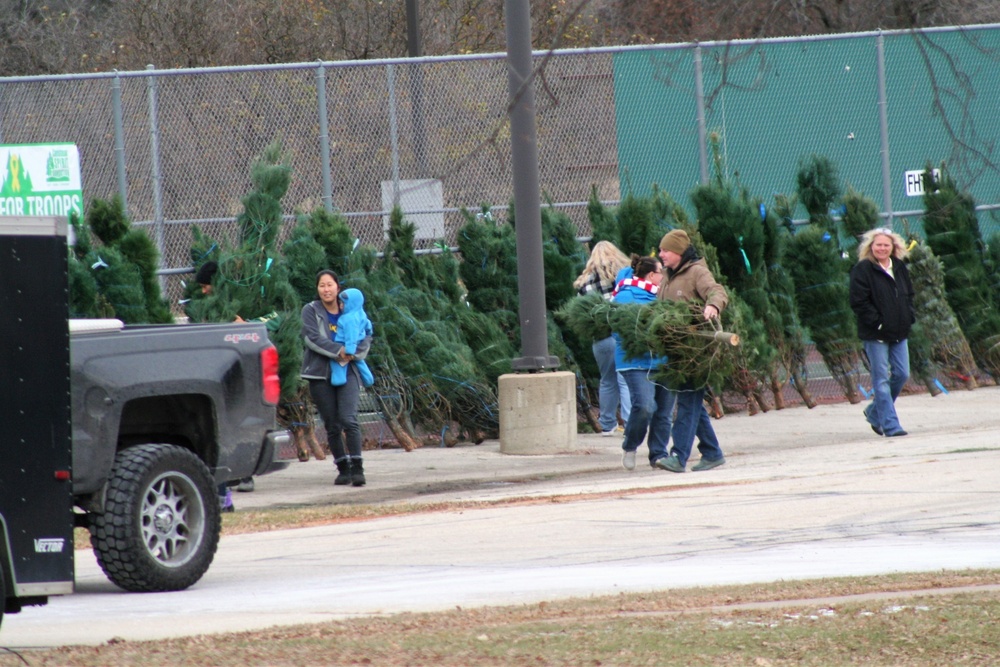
left=619, top=370, right=674, bottom=465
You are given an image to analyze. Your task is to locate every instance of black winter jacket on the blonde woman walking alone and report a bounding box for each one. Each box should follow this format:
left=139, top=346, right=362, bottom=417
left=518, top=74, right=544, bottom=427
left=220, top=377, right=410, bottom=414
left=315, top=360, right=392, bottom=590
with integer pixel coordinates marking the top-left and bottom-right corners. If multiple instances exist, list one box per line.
left=851, top=257, right=916, bottom=343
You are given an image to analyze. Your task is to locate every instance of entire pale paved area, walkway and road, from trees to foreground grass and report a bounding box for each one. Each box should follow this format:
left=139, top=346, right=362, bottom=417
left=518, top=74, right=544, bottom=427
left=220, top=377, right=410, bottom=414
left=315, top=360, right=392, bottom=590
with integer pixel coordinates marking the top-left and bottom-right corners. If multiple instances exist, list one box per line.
left=0, top=387, right=1000, bottom=648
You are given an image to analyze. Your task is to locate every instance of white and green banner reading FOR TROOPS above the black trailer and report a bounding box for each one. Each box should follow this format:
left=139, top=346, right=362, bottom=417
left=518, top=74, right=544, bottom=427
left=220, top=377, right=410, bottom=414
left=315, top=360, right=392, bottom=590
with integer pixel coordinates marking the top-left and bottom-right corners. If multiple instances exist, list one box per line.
left=0, top=144, right=83, bottom=218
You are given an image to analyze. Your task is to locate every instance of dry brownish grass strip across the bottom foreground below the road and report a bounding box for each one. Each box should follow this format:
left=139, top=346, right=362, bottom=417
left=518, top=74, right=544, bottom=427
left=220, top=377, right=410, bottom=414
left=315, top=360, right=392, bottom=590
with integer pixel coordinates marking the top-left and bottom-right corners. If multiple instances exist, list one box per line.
left=7, top=571, right=1000, bottom=667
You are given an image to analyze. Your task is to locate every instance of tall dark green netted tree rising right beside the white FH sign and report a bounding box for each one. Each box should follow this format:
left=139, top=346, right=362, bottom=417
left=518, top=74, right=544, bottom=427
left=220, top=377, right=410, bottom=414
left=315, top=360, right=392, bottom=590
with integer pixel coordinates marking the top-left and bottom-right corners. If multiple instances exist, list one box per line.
left=924, top=165, right=1000, bottom=381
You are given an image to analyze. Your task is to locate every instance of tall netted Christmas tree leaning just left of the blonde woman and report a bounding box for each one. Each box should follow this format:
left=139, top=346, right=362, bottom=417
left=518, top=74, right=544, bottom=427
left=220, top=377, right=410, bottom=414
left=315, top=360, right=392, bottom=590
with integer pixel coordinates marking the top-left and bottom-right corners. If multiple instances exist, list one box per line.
left=785, top=155, right=861, bottom=403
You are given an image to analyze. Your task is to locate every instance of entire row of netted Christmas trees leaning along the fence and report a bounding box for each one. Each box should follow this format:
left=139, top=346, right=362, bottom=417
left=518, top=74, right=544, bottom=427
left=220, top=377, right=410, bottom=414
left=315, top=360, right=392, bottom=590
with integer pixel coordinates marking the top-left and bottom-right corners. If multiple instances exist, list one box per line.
left=70, top=144, right=1000, bottom=455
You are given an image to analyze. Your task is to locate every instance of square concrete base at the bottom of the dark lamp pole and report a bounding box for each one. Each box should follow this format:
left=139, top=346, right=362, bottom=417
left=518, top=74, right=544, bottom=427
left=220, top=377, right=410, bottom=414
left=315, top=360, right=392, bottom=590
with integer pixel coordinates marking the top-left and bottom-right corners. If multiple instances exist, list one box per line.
left=498, top=371, right=576, bottom=454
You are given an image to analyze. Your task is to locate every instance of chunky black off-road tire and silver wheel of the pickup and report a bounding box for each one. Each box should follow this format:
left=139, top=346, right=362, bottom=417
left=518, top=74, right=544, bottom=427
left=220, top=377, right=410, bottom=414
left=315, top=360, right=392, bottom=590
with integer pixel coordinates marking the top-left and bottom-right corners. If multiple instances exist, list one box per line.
left=90, top=444, right=221, bottom=592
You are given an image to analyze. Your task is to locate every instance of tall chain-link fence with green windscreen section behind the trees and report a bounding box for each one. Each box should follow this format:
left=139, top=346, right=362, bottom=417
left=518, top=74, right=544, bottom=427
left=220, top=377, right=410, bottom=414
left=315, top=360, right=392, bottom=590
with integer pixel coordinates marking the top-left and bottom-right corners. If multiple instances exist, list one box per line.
left=0, top=26, right=1000, bottom=284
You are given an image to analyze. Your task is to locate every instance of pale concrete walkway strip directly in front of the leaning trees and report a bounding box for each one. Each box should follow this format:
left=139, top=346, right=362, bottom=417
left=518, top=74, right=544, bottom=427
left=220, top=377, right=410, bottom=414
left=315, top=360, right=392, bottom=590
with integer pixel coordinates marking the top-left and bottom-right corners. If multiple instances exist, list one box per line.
left=233, top=387, right=1000, bottom=511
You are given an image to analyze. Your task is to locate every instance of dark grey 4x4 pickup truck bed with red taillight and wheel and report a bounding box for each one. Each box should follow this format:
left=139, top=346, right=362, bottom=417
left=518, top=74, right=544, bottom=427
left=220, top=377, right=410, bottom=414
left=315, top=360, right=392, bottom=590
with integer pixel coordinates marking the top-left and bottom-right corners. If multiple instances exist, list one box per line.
left=70, top=320, right=295, bottom=591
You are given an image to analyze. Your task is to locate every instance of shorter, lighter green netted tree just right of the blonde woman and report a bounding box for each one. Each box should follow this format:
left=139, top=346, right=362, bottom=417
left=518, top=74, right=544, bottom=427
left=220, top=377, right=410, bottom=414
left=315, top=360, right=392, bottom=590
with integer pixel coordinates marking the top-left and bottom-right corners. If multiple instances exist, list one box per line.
left=907, top=242, right=977, bottom=394
